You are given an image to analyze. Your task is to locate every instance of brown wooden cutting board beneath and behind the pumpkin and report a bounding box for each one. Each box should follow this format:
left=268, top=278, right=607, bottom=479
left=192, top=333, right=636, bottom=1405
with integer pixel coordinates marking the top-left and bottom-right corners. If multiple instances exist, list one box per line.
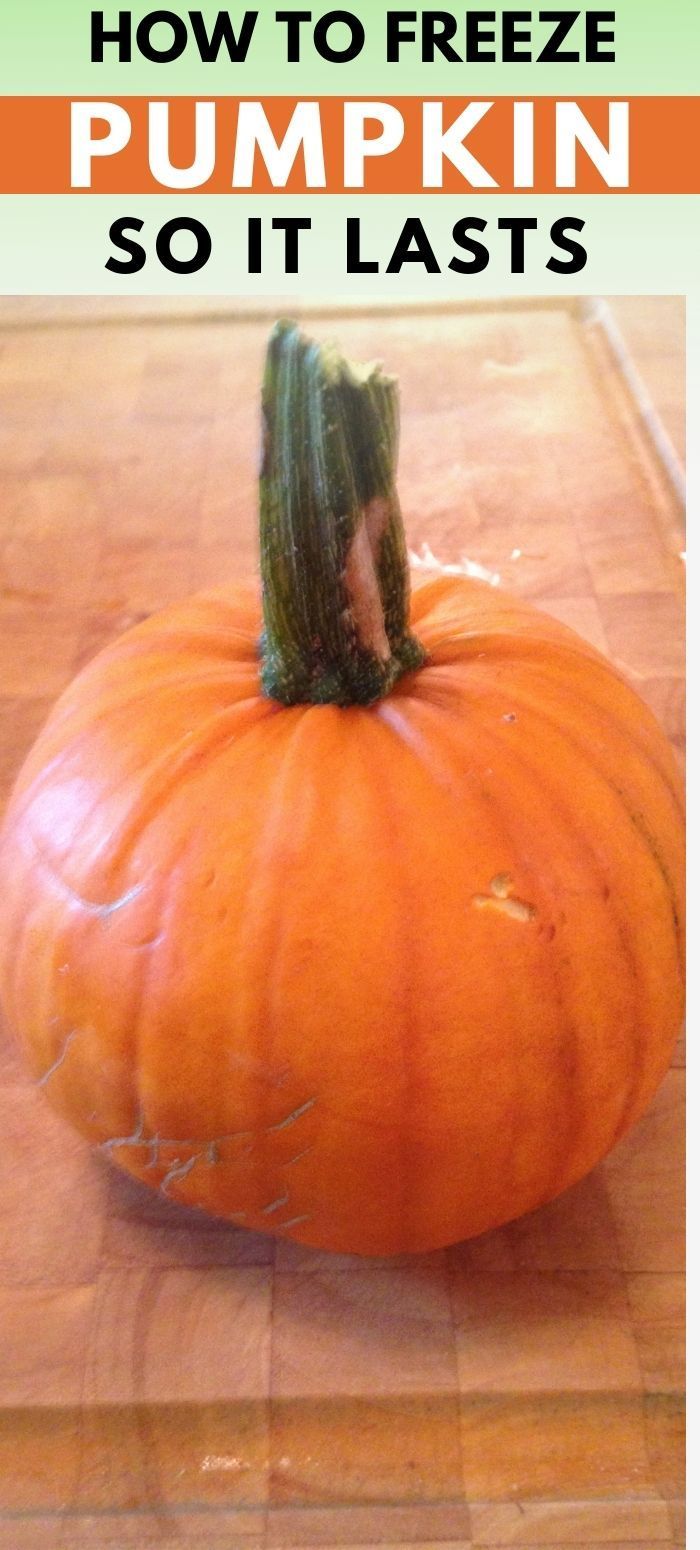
left=0, top=299, right=683, bottom=1550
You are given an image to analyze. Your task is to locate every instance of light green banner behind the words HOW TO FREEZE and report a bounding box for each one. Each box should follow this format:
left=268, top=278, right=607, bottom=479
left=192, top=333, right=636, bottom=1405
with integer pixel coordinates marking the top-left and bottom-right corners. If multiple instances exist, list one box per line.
left=0, top=0, right=698, bottom=96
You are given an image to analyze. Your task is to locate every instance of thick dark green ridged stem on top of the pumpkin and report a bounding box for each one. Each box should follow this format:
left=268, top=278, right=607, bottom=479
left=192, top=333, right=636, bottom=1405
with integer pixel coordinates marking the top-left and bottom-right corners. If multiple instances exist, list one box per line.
left=260, top=322, right=424, bottom=705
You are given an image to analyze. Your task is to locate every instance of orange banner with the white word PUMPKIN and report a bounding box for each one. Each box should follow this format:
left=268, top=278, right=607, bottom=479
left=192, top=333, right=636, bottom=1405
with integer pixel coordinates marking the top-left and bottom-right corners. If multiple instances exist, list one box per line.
left=0, top=96, right=700, bottom=194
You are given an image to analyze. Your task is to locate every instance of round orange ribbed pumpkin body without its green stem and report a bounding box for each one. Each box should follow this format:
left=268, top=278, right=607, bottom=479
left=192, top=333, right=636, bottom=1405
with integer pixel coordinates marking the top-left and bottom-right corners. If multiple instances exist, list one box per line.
left=0, top=578, right=683, bottom=1254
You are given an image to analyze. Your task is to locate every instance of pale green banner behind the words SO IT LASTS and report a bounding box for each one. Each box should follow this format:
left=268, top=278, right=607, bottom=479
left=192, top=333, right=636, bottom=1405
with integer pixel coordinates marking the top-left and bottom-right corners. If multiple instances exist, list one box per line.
left=0, top=194, right=700, bottom=302
